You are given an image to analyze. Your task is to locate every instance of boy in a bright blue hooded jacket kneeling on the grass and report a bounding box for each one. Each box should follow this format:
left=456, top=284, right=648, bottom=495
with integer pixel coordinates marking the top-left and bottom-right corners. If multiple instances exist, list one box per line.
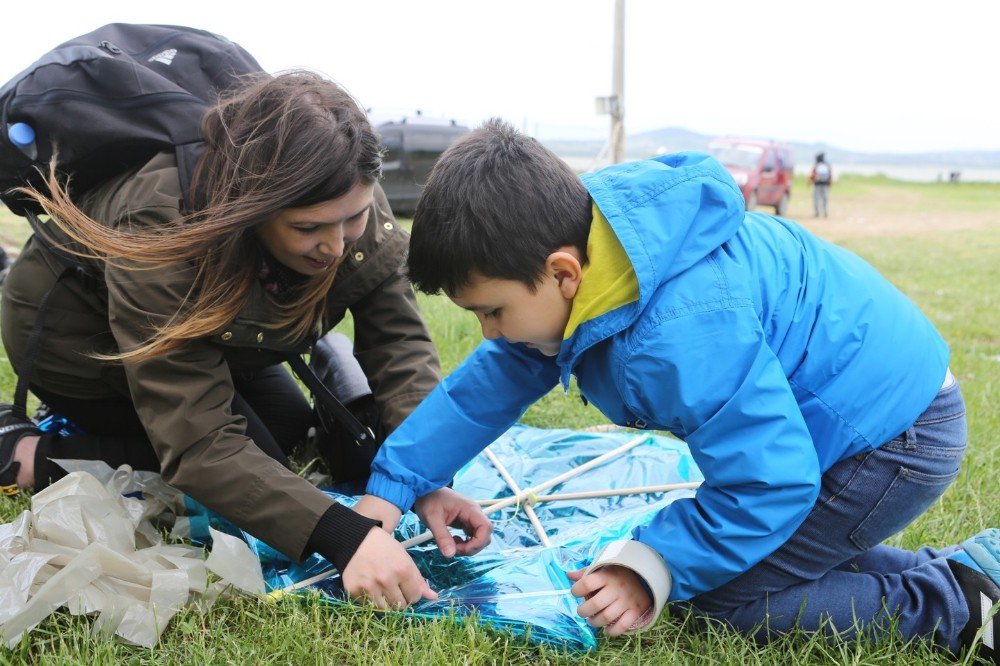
left=345, top=121, right=1000, bottom=650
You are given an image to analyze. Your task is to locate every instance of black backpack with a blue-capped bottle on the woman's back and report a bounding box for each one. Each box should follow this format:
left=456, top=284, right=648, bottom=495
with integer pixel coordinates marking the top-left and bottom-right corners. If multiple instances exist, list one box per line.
left=0, top=23, right=263, bottom=215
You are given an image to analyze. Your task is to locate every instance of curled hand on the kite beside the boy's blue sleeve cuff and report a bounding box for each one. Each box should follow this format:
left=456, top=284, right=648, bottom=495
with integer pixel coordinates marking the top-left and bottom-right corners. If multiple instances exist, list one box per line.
left=413, top=488, right=493, bottom=557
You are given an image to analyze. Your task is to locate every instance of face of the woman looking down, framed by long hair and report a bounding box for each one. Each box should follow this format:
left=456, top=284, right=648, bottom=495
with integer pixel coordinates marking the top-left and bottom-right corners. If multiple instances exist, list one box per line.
left=257, top=182, right=375, bottom=275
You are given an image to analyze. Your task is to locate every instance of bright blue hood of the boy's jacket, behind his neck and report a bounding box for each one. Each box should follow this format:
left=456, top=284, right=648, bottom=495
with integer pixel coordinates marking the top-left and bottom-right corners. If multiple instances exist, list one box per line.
left=557, top=152, right=746, bottom=378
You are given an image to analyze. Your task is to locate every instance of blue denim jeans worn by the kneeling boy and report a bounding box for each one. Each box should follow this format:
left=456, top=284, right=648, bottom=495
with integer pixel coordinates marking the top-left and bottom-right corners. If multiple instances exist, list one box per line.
left=691, top=383, right=969, bottom=650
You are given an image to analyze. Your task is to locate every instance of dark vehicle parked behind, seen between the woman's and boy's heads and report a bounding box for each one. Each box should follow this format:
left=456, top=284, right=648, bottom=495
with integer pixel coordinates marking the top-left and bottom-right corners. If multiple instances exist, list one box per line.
left=375, top=116, right=469, bottom=215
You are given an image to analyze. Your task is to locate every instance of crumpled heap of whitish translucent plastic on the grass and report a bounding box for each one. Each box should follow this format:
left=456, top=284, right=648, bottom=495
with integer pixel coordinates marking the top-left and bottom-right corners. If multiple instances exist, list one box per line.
left=0, top=461, right=264, bottom=647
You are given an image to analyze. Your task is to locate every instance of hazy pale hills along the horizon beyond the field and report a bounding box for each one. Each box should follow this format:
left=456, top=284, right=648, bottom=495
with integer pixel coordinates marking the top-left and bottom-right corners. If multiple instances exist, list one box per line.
left=545, top=127, right=1000, bottom=169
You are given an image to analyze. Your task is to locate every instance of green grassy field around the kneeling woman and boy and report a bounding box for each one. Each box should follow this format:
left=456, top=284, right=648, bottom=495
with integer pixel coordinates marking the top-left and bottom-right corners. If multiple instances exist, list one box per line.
left=0, top=177, right=1000, bottom=665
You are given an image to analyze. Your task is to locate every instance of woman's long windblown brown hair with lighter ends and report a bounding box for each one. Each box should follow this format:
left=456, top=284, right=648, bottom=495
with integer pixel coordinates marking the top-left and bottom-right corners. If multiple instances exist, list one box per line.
left=26, top=70, right=382, bottom=362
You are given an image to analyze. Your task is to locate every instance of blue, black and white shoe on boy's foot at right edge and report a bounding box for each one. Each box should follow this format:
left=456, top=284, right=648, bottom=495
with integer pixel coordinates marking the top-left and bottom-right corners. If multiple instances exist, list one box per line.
left=948, top=529, right=1000, bottom=664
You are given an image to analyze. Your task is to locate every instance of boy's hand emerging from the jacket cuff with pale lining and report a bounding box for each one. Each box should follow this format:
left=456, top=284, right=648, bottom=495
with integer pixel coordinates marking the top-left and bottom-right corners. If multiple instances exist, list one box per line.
left=566, top=564, right=653, bottom=637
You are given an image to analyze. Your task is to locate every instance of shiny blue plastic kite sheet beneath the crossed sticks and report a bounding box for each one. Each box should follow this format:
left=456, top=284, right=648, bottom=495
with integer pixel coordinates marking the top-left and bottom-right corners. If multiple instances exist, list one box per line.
left=240, top=426, right=703, bottom=651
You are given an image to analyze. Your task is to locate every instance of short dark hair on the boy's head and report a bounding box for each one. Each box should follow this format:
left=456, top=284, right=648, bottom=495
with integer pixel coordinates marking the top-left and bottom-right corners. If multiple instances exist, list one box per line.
left=408, top=118, right=592, bottom=294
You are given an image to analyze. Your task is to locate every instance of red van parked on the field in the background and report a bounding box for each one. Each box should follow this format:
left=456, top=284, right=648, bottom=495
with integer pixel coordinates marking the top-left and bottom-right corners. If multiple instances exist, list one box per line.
left=708, top=137, right=794, bottom=215
